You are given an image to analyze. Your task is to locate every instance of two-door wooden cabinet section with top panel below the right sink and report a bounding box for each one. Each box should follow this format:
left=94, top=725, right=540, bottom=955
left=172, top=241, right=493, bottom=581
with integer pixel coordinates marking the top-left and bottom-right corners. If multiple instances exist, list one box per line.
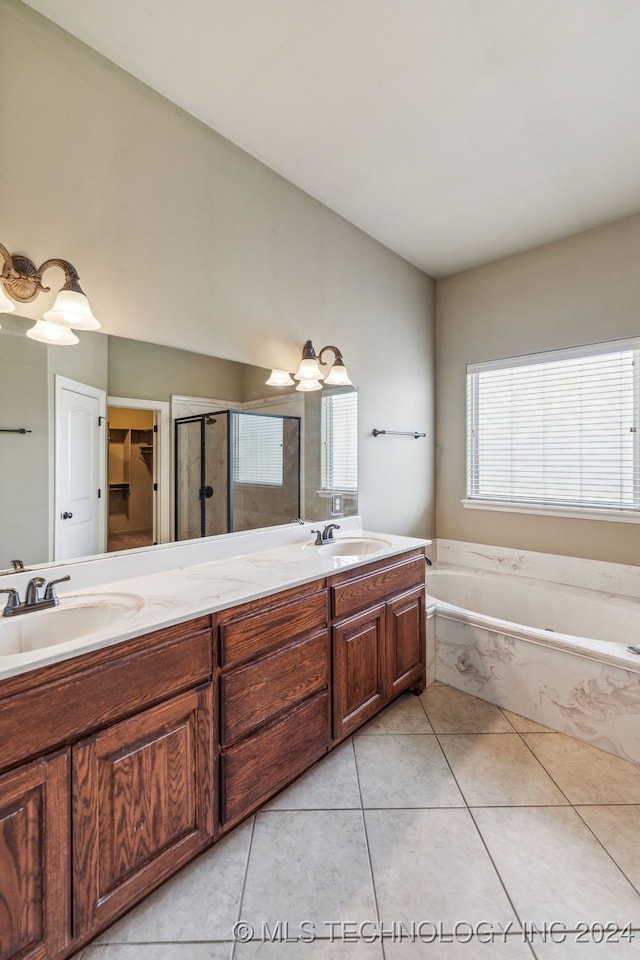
left=330, top=552, right=426, bottom=742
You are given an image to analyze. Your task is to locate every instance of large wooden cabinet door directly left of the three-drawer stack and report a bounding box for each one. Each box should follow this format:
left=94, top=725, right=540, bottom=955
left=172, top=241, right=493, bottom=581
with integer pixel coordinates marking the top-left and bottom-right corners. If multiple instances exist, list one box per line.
left=72, top=684, right=213, bottom=936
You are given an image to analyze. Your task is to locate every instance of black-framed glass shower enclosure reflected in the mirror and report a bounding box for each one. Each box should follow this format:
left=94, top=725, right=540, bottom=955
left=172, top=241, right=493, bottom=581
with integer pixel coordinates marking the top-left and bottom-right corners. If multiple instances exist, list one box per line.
left=174, top=410, right=300, bottom=540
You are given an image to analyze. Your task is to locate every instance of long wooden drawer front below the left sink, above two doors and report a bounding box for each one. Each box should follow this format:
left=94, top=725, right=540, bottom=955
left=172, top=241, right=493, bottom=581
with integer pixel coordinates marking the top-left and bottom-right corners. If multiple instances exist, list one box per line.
left=0, top=628, right=212, bottom=767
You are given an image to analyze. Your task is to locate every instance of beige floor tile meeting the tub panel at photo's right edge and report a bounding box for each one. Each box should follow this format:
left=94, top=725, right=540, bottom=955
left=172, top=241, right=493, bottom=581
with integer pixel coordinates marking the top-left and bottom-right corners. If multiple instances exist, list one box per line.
left=522, top=733, right=640, bottom=804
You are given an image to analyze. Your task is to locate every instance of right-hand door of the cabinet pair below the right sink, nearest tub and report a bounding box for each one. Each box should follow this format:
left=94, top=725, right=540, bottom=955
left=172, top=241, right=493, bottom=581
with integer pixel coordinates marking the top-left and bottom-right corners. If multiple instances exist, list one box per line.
left=386, top=587, right=426, bottom=698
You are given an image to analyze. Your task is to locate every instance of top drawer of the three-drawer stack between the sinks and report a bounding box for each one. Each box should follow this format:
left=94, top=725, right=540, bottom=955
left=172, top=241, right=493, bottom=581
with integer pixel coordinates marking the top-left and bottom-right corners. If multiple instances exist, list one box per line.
left=220, top=589, right=327, bottom=666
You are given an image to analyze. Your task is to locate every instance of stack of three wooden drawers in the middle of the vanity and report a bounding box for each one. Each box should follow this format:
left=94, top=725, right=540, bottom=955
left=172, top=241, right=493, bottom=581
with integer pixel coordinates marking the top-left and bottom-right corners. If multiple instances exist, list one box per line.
left=219, top=581, right=331, bottom=831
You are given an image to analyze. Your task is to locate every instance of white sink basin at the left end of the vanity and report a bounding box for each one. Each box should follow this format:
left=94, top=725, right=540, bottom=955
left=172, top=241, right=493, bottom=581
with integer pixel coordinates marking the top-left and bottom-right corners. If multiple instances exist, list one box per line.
left=0, top=593, right=144, bottom=657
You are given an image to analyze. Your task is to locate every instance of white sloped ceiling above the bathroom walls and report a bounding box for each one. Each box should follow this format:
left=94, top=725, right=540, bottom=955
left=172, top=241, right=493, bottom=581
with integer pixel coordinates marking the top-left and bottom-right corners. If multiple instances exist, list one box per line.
left=22, top=0, right=640, bottom=277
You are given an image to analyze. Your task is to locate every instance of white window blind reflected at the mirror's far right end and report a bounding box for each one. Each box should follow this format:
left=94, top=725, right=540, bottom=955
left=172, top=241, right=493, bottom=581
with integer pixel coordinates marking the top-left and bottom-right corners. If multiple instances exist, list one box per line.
left=321, top=390, right=358, bottom=493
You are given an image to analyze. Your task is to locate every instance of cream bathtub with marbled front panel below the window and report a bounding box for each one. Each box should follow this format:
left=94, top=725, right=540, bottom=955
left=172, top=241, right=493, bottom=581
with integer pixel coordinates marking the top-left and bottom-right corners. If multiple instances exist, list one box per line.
left=427, top=564, right=640, bottom=762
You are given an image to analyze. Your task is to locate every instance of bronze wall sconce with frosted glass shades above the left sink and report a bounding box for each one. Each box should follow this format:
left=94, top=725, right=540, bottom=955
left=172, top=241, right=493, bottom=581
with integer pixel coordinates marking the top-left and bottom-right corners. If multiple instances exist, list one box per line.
left=0, top=243, right=100, bottom=345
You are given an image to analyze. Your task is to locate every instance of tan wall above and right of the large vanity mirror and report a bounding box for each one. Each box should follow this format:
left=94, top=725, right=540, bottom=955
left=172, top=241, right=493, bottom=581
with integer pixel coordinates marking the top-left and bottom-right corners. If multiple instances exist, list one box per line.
left=0, top=0, right=434, bottom=535
